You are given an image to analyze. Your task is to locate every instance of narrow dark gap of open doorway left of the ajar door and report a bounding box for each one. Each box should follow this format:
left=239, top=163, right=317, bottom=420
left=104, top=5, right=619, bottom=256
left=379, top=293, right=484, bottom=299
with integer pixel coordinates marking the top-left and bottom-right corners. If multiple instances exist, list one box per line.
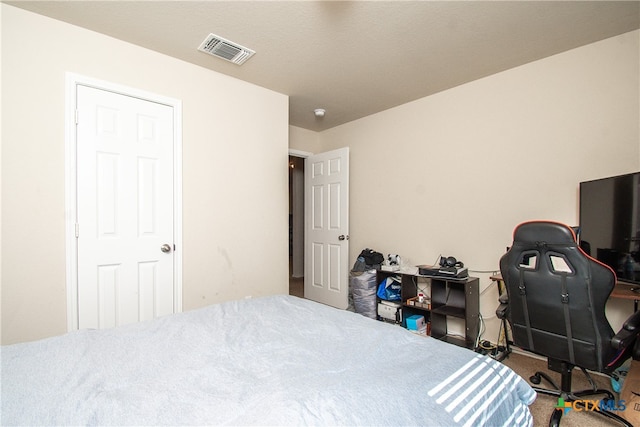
left=289, top=155, right=304, bottom=298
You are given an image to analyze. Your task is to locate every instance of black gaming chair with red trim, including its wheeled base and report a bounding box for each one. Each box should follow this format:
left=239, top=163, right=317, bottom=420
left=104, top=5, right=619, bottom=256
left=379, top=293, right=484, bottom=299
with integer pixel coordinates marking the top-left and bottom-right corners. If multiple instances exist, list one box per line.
left=497, top=221, right=640, bottom=426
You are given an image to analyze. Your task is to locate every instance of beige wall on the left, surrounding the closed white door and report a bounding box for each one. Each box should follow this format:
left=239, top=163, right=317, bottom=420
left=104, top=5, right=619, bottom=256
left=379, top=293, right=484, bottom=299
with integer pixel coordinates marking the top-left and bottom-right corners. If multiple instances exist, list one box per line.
left=1, top=4, right=289, bottom=344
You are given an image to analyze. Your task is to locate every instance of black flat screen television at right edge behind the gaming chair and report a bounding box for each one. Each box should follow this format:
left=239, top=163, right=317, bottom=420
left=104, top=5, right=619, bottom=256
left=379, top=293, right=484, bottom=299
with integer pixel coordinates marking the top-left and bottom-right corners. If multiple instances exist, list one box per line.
left=580, top=172, right=640, bottom=284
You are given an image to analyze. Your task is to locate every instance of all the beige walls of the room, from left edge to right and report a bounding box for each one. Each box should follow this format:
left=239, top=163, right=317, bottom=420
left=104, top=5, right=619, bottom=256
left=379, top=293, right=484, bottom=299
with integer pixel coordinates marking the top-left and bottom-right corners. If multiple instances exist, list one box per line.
left=0, top=4, right=640, bottom=344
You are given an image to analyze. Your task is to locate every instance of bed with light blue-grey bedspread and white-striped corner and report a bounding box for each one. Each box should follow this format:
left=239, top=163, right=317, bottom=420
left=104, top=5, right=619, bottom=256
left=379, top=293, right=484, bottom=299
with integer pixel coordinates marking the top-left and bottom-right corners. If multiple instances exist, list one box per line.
left=1, top=295, right=535, bottom=426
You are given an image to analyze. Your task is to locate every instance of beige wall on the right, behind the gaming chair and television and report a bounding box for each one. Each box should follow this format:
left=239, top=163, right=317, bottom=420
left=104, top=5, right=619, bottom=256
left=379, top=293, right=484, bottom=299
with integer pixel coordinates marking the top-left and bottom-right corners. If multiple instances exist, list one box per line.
left=320, top=31, right=640, bottom=341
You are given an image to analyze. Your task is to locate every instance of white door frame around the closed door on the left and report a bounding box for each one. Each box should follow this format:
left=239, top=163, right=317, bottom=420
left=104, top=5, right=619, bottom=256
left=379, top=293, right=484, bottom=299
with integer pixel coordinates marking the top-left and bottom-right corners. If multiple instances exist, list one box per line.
left=65, top=72, right=182, bottom=331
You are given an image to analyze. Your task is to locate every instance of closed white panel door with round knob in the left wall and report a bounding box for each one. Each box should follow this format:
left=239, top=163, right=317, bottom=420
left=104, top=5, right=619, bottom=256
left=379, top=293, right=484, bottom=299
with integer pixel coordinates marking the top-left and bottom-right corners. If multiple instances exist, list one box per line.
left=76, top=85, right=175, bottom=329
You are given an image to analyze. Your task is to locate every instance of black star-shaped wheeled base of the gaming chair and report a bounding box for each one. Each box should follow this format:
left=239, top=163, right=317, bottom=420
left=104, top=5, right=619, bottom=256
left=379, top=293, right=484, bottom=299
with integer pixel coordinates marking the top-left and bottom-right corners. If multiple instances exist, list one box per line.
left=530, top=367, right=633, bottom=427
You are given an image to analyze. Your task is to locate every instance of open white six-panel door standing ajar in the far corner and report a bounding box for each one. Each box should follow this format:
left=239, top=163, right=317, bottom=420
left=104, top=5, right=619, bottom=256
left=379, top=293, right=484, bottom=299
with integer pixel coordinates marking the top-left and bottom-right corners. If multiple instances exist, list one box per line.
left=304, top=148, right=349, bottom=309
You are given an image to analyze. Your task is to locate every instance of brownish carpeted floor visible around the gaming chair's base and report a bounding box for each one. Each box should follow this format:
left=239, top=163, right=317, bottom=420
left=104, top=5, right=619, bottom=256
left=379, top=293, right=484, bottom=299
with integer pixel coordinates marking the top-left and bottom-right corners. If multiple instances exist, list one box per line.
left=503, top=353, right=620, bottom=427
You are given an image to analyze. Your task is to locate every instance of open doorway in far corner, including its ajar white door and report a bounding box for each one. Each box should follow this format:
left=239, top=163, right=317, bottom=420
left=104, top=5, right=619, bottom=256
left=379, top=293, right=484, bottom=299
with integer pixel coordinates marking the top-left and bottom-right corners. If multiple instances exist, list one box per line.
left=288, top=147, right=349, bottom=309
